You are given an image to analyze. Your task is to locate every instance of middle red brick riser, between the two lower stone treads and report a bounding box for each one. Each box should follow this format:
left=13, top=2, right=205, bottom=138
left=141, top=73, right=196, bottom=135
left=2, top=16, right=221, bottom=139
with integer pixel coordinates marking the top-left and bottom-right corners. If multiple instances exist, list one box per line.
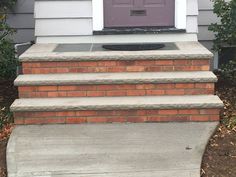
left=19, top=83, right=214, bottom=98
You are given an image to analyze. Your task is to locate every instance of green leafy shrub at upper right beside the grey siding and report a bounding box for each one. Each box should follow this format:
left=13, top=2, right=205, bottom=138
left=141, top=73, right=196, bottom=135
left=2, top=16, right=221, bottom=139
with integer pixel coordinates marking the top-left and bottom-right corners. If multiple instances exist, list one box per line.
left=209, top=0, right=236, bottom=51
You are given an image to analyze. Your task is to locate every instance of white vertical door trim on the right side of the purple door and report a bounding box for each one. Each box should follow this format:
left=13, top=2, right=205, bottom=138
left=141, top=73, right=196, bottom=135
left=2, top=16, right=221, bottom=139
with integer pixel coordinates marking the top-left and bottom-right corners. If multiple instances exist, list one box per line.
left=175, top=0, right=187, bottom=29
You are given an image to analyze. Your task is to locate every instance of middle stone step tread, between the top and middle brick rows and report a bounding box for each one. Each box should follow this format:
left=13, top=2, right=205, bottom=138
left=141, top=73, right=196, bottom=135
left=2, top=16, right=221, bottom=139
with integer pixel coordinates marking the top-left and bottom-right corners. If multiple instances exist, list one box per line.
left=14, top=71, right=217, bottom=86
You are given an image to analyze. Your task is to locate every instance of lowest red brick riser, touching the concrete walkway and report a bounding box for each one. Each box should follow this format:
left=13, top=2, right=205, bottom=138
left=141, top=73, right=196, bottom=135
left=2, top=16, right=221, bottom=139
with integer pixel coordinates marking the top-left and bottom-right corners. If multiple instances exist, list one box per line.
left=14, top=109, right=220, bottom=124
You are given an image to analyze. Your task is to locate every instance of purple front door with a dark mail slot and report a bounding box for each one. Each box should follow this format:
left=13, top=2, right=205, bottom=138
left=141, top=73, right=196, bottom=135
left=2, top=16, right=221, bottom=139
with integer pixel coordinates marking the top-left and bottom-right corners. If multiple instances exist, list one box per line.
left=104, top=0, right=175, bottom=27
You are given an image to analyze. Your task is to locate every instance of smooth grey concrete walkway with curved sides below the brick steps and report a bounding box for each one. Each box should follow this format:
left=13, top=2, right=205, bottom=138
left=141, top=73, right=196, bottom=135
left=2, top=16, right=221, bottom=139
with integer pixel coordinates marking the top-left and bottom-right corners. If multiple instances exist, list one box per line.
left=7, top=122, right=217, bottom=177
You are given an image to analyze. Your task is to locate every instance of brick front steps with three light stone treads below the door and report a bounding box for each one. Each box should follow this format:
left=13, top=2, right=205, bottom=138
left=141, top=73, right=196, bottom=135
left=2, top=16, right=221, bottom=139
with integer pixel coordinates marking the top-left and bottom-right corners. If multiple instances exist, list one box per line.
left=11, top=42, right=223, bottom=124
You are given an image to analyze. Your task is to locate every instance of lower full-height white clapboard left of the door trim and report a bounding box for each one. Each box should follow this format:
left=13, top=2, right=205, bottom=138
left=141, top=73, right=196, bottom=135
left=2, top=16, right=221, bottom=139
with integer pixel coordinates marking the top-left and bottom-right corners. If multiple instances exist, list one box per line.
left=35, top=19, right=92, bottom=36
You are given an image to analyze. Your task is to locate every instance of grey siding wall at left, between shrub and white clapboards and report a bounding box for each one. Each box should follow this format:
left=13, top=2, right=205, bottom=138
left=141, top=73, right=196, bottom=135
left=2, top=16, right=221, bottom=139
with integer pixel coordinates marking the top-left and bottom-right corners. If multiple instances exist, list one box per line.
left=7, top=0, right=35, bottom=43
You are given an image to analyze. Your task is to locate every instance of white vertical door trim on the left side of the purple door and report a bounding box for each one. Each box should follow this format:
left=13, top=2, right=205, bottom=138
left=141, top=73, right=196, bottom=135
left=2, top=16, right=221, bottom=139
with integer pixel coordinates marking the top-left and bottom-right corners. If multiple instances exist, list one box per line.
left=92, top=0, right=104, bottom=31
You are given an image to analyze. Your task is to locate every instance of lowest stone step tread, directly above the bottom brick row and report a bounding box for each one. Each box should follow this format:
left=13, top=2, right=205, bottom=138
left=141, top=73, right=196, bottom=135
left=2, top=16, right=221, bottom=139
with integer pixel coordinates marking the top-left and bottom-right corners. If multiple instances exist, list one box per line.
left=11, top=95, right=223, bottom=111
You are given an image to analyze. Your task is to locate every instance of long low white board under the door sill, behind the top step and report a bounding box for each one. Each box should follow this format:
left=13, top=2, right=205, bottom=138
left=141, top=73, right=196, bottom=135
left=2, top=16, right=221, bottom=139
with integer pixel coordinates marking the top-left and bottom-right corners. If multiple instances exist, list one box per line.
left=37, top=33, right=198, bottom=43
